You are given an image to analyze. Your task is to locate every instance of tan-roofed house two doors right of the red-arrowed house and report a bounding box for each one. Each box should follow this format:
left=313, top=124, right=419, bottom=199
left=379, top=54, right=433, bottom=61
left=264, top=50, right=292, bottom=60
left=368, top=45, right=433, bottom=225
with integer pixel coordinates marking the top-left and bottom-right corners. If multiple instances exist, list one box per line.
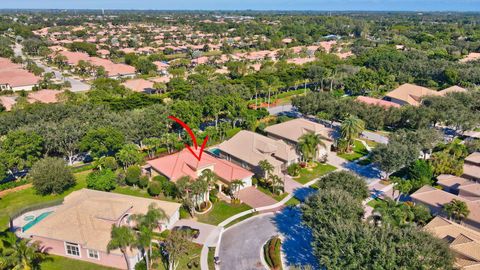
left=265, top=118, right=335, bottom=158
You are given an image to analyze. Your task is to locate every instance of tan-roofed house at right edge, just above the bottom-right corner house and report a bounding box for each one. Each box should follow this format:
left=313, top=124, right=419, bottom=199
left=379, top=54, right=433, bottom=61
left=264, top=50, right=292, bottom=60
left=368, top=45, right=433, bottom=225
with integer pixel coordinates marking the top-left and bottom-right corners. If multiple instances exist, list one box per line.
left=411, top=186, right=480, bottom=231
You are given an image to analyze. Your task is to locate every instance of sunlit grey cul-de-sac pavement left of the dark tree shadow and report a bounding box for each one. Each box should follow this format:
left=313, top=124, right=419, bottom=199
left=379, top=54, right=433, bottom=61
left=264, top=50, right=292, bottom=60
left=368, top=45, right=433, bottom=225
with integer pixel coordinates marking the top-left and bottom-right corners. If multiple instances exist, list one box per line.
left=219, top=214, right=278, bottom=270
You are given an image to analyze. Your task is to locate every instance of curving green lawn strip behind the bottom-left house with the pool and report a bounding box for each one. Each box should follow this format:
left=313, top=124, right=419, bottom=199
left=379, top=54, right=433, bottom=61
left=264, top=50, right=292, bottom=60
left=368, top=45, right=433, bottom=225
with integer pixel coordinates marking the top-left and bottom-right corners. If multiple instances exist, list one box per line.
left=0, top=171, right=89, bottom=231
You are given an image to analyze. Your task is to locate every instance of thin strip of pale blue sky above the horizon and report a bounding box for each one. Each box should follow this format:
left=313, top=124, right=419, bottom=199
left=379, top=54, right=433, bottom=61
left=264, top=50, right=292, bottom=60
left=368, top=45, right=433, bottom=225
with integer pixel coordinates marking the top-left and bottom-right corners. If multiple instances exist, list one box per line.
left=0, top=0, right=480, bottom=11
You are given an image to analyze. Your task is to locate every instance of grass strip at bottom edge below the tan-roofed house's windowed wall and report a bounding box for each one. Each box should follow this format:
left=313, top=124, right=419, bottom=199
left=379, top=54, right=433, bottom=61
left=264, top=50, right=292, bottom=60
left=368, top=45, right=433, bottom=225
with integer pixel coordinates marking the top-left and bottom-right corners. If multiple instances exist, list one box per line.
left=40, top=255, right=115, bottom=270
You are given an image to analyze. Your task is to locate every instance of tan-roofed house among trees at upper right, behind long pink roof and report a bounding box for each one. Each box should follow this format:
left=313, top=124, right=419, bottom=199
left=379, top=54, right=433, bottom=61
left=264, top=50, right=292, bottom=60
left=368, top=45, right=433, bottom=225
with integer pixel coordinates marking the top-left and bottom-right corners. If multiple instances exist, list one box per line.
left=383, top=83, right=440, bottom=106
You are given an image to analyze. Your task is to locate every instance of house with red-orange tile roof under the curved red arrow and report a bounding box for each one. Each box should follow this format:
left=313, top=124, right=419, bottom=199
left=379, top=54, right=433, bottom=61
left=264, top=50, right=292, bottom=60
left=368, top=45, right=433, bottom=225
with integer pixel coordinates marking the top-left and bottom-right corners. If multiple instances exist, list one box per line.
left=146, top=149, right=253, bottom=192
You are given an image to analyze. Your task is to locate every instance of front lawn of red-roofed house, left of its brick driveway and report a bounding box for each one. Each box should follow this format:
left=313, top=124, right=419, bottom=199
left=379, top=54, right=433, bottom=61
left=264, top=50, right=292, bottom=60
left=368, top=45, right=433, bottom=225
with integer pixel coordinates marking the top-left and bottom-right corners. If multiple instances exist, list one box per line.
left=198, top=201, right=251, bottom=225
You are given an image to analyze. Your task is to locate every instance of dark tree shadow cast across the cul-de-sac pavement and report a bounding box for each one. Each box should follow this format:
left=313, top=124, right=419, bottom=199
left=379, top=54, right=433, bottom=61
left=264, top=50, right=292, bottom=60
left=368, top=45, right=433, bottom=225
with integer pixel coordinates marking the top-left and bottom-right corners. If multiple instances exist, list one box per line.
left=272, top=207, right=321, bottom=269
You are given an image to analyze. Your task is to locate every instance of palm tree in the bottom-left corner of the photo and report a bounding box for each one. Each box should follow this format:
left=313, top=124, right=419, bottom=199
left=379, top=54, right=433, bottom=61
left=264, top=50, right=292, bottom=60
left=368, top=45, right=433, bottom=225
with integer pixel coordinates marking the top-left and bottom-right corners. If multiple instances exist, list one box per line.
left=0, top=232, right=46, bottom=270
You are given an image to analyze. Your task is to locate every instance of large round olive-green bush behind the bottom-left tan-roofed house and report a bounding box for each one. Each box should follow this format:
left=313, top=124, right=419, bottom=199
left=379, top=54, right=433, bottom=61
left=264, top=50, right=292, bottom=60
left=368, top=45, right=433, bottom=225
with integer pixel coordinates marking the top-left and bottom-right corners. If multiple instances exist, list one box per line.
left=29, top=157, right=75, bottom=195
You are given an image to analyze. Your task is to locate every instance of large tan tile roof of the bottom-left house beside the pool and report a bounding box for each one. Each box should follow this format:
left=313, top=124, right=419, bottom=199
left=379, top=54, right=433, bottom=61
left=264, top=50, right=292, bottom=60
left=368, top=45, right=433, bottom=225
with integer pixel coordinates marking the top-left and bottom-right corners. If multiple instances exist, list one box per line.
left=27, top=189, right=180, bottom=254
